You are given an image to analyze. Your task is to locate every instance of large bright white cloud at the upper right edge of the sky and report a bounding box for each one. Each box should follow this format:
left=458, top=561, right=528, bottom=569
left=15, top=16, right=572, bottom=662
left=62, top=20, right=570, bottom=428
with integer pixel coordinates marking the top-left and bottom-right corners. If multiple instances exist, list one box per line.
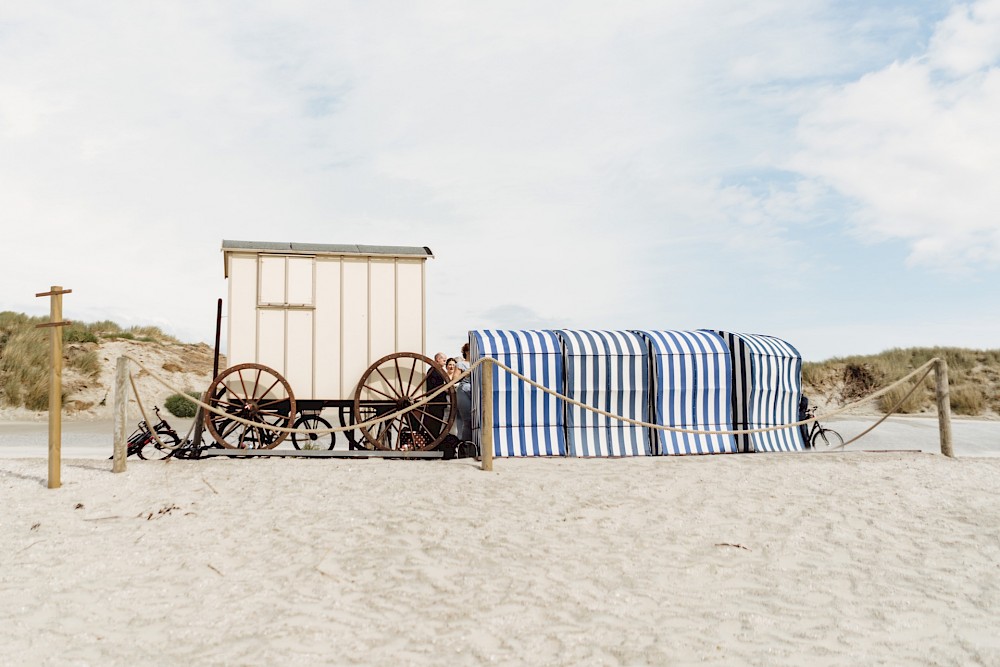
left=790, top=1, right=1000, bottom=272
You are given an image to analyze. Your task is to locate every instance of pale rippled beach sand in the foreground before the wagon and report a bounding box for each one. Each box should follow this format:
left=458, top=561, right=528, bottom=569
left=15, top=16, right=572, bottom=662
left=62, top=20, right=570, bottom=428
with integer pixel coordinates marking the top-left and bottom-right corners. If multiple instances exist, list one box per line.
left=0, top=452, right=1000, bottom=665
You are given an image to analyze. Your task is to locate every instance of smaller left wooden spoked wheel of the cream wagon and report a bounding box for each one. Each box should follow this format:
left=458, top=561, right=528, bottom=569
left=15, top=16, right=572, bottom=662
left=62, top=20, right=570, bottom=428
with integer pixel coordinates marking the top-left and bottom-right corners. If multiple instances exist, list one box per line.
left=205, top=364, right=295, bottom=449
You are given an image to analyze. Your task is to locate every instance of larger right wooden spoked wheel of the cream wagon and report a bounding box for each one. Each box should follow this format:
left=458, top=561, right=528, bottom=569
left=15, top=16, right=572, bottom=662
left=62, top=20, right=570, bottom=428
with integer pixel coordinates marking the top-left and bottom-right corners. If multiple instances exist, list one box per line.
left=354, top=352, right=455, bottom=451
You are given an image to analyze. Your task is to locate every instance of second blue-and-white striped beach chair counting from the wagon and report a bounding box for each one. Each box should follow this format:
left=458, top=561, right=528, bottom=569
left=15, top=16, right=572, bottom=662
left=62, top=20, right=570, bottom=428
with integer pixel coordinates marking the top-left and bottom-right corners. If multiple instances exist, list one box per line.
left=556, top=331, right=651, bottom=456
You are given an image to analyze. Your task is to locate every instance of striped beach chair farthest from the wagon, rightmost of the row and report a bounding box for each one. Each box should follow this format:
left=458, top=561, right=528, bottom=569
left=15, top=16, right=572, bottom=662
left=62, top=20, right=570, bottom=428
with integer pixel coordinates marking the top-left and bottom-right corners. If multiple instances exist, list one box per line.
left=718, top=331, right=803, bottom=452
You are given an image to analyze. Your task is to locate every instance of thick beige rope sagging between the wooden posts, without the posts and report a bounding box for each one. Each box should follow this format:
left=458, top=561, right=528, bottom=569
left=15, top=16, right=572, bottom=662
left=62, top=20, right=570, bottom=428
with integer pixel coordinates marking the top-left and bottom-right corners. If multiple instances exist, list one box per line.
left=123, top=354, right=938, bottom=444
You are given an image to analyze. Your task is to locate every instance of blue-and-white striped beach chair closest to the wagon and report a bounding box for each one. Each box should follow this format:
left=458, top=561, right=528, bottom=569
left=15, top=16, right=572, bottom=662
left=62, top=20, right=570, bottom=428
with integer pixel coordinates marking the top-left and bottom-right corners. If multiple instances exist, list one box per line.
left=469, top=329, right=566, bottom=456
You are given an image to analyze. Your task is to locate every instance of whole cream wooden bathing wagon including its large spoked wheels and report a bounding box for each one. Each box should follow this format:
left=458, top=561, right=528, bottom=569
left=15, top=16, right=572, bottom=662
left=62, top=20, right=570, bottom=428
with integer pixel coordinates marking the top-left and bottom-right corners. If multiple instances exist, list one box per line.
left=205, top=240, right=455, bottom=451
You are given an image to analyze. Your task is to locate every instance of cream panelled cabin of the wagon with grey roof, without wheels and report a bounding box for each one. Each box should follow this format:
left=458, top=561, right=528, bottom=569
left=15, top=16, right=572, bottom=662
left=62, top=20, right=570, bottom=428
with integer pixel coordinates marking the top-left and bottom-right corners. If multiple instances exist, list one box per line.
left=222, top=240, right=434, bottom=401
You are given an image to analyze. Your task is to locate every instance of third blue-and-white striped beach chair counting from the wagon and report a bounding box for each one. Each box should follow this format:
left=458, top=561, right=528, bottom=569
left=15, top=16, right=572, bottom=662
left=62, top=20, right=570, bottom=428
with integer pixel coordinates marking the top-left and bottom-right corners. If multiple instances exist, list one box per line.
left=635, top=331, right=737, bottom=455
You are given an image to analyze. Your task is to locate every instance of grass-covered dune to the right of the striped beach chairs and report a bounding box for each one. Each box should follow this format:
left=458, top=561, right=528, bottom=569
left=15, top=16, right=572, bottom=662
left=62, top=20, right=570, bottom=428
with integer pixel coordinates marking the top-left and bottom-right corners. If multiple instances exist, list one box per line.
left=802, top=347, right=1000, bottom=415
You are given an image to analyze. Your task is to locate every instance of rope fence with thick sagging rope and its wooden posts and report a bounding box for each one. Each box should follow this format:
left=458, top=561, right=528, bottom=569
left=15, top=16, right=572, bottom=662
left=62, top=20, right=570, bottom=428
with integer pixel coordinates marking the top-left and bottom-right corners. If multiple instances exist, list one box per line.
left=114, top=355, right=954, bottom=472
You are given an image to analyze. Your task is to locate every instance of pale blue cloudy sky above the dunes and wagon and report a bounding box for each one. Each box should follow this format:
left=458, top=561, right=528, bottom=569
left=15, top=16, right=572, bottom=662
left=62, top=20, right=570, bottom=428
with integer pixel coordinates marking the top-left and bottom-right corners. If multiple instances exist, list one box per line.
left=0, top=0, right=1000, bottom=361
